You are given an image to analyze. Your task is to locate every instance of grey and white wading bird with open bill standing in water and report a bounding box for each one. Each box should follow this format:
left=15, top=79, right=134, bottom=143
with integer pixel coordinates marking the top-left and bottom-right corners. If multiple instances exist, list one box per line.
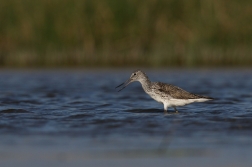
left=116, top=70, right=213, bottom=112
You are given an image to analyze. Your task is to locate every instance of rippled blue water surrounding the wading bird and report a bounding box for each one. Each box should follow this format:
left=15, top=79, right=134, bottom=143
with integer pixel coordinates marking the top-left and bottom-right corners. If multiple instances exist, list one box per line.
left=0, top=69, right=252, bottom=166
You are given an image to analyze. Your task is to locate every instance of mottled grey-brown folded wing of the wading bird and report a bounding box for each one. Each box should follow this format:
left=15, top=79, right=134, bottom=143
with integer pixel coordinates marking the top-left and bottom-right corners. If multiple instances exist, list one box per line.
left=155, top=82, right=212, bottom=99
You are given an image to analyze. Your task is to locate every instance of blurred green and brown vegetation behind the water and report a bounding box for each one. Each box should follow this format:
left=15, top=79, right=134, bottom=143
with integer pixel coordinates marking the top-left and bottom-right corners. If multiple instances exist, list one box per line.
left=0, top=0, right=252, bottom=67
